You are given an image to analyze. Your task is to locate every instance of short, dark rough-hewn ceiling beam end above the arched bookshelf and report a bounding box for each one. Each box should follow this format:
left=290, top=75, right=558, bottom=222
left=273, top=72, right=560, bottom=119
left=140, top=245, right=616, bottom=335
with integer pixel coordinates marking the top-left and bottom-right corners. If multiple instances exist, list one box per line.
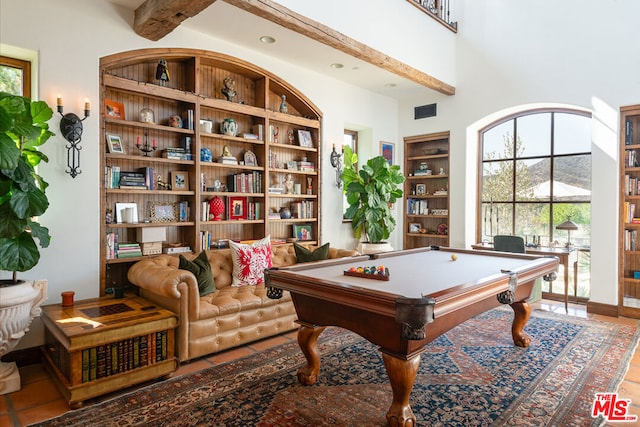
left=133, top=0, right=221, bottom=41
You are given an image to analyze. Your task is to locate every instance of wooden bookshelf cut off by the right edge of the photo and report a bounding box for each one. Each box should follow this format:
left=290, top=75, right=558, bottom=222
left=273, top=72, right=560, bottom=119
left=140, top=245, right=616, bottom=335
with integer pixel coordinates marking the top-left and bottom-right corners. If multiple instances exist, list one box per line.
left=618, top=105, right=640, bottom=318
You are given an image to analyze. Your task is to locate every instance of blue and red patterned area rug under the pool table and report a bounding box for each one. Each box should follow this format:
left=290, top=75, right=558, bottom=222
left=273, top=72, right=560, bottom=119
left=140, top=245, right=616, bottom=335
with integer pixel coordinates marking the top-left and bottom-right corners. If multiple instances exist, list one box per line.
left=32, top=308, right=639, bottom=427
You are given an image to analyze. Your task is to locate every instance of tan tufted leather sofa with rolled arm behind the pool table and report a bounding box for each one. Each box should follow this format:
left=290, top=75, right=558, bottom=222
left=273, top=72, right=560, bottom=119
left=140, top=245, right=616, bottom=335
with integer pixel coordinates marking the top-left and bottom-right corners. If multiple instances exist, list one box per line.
left=128, top=244, right=358, bottom=362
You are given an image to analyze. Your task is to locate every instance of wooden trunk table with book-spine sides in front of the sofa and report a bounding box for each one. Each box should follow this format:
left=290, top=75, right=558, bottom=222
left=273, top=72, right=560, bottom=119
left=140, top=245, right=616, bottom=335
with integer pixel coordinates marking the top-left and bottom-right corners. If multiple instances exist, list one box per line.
left=41, top=296, right=178, bottom=408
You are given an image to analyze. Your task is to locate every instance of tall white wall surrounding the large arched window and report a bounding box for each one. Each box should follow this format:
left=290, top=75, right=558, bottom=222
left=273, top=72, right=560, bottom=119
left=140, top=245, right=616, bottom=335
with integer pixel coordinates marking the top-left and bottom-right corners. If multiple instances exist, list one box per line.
left=399, top=0, right=640, bottom=305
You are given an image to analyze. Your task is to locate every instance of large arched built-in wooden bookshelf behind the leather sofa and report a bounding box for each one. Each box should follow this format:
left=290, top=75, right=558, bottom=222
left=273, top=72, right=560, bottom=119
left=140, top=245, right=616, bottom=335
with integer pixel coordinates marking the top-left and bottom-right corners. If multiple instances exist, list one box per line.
left=100, top=49, right=322, bottom=295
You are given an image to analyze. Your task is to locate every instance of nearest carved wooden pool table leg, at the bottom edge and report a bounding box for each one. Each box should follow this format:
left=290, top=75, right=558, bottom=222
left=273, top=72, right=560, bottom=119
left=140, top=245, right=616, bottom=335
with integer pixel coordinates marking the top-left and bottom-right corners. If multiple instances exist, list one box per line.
left=382, top=352, right=420, bottom=427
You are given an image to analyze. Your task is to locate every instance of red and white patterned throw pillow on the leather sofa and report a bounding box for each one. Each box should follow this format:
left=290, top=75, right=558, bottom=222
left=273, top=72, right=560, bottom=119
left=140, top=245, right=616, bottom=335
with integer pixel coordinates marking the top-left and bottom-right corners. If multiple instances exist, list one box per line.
left=229, top=236, right=273, bottom=286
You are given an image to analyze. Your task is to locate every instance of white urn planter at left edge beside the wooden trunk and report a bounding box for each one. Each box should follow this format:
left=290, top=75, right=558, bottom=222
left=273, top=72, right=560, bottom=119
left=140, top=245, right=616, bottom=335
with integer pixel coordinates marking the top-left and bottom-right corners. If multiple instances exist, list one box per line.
left=0, top=280, right=47, bottom=395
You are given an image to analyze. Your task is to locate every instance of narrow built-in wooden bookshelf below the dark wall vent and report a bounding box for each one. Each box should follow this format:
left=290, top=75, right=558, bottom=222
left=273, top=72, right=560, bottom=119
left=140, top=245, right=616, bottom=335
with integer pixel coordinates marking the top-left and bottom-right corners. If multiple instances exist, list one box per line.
left=403, top=132, right=450, bottom=249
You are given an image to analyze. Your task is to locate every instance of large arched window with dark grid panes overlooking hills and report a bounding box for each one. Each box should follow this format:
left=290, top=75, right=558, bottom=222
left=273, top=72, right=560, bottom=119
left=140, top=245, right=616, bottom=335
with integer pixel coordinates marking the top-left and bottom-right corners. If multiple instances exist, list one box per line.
left=477, top=110, right=591, bottom=298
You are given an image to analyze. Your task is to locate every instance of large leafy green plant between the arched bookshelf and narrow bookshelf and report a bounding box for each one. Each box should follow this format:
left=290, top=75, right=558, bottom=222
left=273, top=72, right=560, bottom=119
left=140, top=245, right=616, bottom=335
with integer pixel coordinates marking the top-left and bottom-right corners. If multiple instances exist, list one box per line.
left=341, top=146, right=405, bottom=247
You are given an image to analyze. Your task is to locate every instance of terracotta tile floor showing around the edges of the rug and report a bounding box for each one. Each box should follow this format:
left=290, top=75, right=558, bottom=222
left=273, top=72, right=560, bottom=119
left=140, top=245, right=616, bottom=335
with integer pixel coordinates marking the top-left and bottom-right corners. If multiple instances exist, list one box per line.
left=0, top=300, right=640, bottom=427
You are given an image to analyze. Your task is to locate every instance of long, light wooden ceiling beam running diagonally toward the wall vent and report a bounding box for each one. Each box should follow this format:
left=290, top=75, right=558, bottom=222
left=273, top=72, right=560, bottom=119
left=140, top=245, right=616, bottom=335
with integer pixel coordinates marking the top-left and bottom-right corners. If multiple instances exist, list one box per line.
left=224, top=0, right=456, bottom=95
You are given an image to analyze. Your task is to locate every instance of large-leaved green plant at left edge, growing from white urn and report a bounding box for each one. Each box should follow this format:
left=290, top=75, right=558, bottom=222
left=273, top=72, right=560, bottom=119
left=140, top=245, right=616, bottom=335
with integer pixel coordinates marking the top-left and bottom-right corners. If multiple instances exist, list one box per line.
left=0, top=92, right=54, bottom=282
